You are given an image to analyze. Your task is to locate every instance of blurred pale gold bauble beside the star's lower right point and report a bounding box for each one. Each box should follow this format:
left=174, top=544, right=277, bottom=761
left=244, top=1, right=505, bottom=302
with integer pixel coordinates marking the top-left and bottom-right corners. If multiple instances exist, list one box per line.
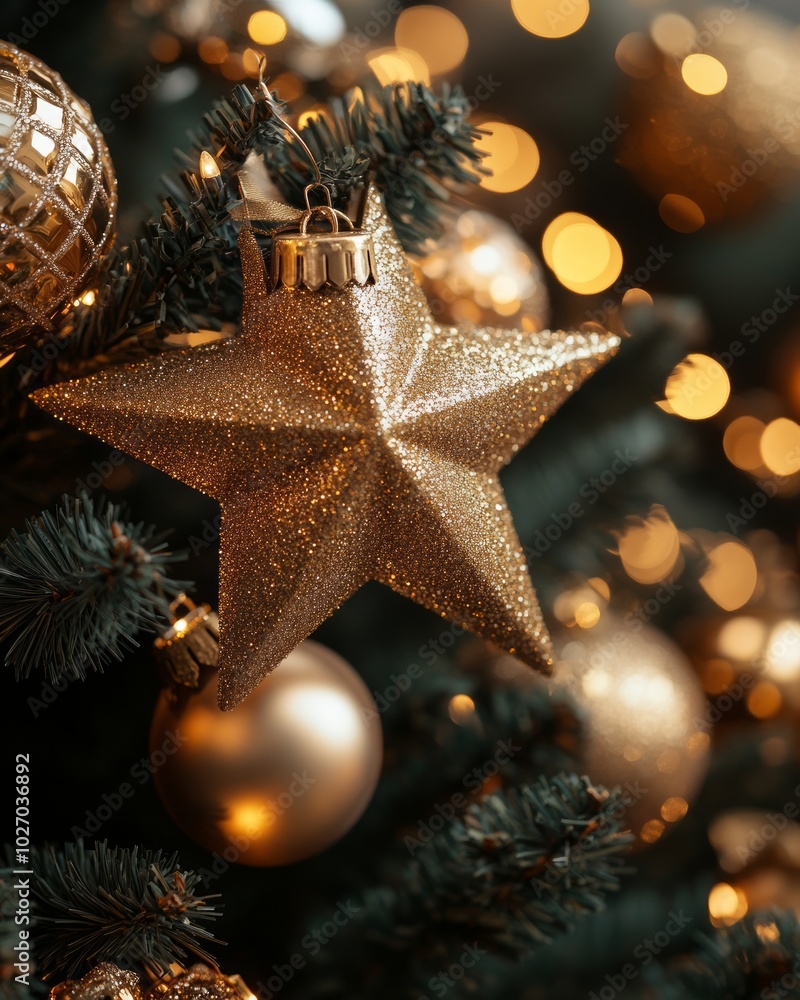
left=555, top=619, right=710, bottom=843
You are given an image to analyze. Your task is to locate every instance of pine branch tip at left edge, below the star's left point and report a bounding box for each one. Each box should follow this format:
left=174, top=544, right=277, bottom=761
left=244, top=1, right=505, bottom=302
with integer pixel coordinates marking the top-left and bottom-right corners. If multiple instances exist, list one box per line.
left=0, top=497, right=188, bottom=683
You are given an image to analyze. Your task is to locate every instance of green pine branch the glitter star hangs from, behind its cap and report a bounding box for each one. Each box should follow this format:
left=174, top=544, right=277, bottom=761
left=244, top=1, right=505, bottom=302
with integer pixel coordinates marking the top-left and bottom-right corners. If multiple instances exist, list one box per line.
left=7, top=84, right=485, bottom=402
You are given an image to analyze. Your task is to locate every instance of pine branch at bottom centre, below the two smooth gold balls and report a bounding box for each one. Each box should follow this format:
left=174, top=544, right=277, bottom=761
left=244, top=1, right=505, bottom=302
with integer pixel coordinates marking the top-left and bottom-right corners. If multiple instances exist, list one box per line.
left=310, top=775, right=633, bottom=997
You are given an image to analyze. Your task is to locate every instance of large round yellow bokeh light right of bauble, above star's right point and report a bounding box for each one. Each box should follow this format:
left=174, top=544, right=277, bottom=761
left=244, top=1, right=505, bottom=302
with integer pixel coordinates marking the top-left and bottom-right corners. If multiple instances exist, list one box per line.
left=542, top=212, right=623, bottom=295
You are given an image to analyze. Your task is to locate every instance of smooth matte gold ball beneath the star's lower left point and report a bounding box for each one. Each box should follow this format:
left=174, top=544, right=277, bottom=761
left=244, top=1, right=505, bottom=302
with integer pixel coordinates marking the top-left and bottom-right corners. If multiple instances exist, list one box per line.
left=150, top=641, right=383, bottom=866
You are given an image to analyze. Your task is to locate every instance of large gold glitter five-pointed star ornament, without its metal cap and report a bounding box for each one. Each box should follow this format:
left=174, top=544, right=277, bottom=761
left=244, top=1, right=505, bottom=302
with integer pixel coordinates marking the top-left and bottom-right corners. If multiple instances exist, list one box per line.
left=33, top=187, right=619, bottom=709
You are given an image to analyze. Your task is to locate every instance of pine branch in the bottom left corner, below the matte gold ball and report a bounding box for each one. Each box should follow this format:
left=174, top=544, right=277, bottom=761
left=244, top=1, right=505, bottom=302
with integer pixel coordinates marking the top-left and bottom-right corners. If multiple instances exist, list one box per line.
left=31, top=841, right=221, bottom=979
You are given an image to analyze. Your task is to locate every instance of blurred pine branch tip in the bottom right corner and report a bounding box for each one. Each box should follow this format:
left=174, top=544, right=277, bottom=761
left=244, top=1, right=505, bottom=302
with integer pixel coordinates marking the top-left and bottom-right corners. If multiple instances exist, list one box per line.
left=653, top=910, right=800, bottom=1000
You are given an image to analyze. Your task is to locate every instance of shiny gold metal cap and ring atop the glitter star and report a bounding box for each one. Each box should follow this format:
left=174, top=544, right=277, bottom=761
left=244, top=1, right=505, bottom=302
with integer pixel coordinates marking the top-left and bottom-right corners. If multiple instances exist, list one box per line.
left=270, top=185, right=377, bottom=292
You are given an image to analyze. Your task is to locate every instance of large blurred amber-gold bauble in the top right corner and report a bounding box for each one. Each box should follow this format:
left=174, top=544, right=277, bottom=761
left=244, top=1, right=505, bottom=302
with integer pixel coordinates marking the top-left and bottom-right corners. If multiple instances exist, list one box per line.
left=618, top=5, right=800, bottom=225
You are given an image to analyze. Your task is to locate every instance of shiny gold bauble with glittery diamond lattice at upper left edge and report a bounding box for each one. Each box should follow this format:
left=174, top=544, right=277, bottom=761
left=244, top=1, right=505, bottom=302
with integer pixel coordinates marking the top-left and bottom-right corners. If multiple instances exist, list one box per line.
left=0, top=41, right=117, bottom=354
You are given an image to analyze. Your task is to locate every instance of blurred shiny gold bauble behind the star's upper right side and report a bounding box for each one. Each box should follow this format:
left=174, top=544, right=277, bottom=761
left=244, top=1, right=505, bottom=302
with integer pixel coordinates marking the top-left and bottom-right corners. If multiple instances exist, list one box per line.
left=412, top=209, right=550, bottom=330
